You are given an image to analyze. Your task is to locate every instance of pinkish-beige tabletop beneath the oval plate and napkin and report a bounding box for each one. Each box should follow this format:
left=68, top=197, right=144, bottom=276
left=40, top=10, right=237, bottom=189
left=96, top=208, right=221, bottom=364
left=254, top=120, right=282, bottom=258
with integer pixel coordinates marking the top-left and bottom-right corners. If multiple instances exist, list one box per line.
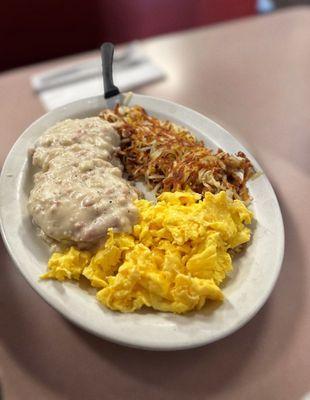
left=0, top=8, right=310, bottom=400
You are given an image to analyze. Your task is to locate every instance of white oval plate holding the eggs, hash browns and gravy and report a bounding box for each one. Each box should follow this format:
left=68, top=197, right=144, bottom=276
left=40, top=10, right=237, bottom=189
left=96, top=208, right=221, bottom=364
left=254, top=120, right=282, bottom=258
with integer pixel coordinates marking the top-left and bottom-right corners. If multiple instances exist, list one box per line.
left=0, top=94, right=284, bottom=350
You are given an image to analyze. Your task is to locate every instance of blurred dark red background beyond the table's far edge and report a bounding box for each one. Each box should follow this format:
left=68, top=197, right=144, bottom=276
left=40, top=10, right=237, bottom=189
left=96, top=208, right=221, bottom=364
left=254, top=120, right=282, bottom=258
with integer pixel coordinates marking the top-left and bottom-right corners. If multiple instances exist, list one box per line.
left=0, top=0, right=310, bottom=71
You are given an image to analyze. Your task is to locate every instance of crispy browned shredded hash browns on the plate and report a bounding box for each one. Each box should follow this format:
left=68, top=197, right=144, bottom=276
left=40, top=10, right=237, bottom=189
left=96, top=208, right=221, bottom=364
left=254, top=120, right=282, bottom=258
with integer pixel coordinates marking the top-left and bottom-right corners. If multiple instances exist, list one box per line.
left=100, top=105, right=255, bottom=203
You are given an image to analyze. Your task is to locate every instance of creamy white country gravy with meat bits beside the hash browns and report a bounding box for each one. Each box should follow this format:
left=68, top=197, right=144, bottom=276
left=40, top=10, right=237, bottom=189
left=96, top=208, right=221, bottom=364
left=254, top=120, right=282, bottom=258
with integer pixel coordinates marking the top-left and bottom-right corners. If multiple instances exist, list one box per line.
left=28, top=117, right=137, bottom=247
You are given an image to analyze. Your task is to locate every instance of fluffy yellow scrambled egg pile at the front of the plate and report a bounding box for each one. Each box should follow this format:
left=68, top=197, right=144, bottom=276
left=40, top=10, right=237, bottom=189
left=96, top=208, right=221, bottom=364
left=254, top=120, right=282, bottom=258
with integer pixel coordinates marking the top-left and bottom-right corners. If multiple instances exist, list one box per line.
left=42, top=192, right=252, bottom=313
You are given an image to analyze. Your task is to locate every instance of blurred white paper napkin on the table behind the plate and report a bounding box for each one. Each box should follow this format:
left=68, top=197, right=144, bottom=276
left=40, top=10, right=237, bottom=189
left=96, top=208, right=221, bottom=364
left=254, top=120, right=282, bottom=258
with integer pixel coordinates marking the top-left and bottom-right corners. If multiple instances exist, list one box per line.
left=30, top=42, right=165, bottom=110
